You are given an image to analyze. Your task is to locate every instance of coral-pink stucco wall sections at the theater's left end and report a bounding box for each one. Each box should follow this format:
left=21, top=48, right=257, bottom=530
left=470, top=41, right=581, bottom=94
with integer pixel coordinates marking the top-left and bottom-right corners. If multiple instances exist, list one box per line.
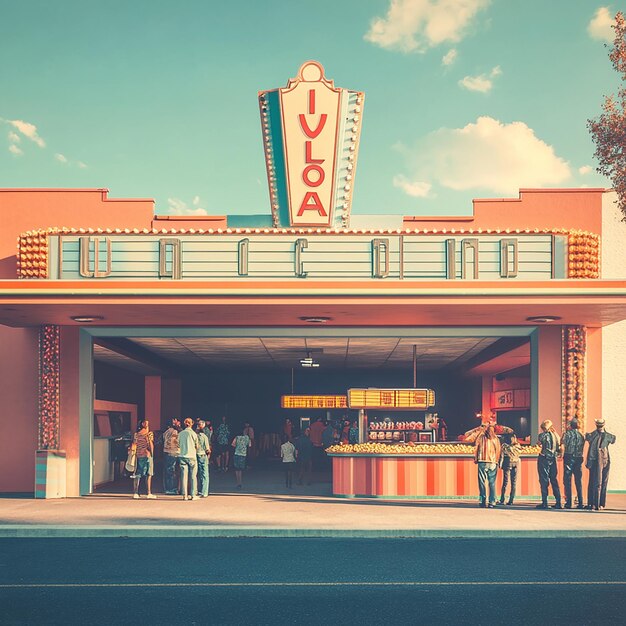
left=0, top=189, right=154, bottom=495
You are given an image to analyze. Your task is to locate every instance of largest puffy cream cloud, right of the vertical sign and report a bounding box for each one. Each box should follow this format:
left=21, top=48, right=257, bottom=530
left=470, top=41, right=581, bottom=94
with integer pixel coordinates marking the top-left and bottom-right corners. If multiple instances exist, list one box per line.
left=398, top=117, right=571, bottom=194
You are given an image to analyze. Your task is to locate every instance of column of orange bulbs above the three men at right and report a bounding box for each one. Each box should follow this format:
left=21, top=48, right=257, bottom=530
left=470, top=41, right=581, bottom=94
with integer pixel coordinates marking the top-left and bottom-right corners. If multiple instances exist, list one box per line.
left=561, top=326, right=587, bottom=432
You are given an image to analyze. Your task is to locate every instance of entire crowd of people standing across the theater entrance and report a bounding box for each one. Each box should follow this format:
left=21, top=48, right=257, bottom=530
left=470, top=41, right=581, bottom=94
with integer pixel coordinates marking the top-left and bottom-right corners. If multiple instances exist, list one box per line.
left=127, top=417, right=615, bottom=511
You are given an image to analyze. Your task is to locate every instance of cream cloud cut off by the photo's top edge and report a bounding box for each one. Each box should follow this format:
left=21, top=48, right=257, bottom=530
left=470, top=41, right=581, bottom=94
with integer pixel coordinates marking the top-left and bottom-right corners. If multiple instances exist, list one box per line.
left=365, top=0, right=491, bottom=52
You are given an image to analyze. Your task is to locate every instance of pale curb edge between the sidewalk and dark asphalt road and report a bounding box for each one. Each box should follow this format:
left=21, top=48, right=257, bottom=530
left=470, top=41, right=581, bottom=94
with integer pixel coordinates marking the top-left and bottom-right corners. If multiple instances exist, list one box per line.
left=0, top=525, right=626, bottom=539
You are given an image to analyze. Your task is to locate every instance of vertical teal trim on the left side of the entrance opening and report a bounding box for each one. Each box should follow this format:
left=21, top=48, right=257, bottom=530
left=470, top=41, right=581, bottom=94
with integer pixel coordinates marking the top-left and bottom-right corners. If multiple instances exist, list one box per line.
left=78, top=328, right=93, bottom=496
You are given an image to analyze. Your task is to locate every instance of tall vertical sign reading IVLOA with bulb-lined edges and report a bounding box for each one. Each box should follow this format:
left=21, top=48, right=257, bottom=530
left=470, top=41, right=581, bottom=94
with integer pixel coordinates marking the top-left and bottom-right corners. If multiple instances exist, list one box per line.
left=259, top=61, right=363, bottom=228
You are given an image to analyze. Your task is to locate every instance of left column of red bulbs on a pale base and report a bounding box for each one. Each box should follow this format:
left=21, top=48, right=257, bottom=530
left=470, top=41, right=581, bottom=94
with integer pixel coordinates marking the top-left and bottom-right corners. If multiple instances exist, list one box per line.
left=35, top=324, right=66, bottom=498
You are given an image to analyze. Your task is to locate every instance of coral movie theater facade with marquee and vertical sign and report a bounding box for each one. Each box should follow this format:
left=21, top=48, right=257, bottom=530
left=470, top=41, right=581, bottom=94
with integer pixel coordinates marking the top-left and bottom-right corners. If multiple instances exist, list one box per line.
left=0, top=62, right=626, bottom=497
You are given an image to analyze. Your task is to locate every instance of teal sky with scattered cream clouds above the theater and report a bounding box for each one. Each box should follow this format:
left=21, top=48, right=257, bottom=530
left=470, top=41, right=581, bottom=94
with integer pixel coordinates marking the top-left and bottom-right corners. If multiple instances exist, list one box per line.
left=0, top=0, right=626, bottom=215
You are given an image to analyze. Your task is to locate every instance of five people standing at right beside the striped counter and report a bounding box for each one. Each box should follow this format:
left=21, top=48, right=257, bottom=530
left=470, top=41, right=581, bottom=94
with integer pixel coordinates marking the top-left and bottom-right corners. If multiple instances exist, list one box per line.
left=465, top=419, right=615, bottom=511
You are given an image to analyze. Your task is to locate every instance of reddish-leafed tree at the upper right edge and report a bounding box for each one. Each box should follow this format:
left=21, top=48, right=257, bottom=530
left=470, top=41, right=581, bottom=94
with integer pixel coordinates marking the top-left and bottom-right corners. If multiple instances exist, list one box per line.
left=587, top=11, right=626, bottom=221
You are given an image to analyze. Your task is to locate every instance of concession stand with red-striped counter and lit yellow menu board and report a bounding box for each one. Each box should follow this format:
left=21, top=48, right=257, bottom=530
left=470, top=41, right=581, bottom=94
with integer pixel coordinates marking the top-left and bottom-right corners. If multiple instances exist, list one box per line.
left=326, top=389, right=539, bottom=498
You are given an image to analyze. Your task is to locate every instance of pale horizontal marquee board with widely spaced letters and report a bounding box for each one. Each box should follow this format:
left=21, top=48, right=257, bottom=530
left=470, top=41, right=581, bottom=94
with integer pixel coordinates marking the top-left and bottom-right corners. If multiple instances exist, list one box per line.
left=48, top=232, right=567, bottom=281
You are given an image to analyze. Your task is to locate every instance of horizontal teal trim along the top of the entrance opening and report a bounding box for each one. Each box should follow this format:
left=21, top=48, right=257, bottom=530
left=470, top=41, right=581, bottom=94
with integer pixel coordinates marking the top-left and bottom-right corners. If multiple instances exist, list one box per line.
left=82, top=326, right=536, bottom=336
